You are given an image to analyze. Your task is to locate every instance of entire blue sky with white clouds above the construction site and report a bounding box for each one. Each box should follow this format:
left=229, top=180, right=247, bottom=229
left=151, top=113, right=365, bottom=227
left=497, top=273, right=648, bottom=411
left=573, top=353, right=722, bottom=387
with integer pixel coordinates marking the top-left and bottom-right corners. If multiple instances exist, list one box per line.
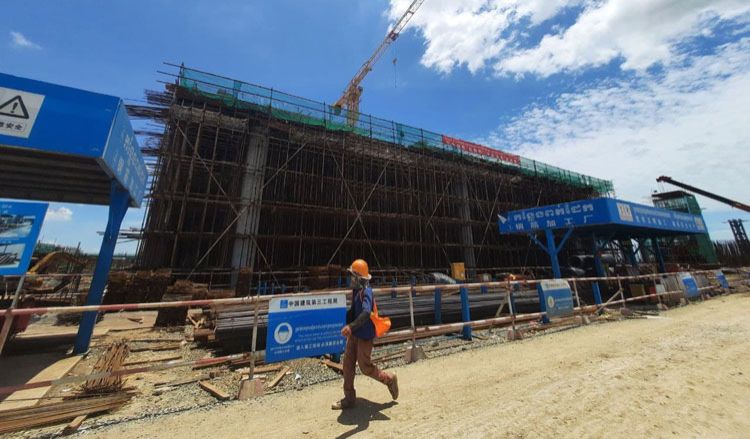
left=0, top=0, right=750, bottom=251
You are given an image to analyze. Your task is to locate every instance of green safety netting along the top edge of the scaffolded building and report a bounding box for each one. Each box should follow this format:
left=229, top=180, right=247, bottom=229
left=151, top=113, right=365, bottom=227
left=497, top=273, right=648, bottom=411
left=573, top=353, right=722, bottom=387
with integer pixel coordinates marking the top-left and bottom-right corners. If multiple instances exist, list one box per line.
left=179, top=67, right=614, bottom=194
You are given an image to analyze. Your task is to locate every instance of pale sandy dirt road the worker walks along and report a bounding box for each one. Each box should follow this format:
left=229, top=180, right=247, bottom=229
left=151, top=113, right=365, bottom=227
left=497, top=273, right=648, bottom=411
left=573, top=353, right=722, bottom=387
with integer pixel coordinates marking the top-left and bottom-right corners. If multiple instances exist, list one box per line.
left=69, top=293, right=750, bottom=439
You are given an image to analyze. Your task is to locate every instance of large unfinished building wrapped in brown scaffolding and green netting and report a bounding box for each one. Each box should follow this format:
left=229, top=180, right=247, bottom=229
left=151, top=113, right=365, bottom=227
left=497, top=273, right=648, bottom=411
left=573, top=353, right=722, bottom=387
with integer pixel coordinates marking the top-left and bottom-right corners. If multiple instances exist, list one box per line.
left=129, top=66, right=612, bottom=287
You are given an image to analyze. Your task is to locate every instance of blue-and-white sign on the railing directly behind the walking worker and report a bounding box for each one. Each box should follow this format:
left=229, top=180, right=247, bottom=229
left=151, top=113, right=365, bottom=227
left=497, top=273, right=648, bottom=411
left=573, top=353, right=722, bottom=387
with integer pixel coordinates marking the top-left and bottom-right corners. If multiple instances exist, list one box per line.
left=266, top=294, right=346, bottom=363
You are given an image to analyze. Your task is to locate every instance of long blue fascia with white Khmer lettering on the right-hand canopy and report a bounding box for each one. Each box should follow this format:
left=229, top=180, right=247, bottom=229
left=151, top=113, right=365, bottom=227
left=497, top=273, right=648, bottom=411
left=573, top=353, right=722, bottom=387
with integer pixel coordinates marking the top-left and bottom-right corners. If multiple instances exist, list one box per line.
left=499, top=198, right=706, bottom=233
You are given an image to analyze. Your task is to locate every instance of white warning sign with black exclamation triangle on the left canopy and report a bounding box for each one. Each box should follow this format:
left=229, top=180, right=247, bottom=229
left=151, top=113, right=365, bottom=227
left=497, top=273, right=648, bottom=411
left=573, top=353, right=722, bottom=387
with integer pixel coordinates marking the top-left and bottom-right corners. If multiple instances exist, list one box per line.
left=0, top=87, right=44, bottom=139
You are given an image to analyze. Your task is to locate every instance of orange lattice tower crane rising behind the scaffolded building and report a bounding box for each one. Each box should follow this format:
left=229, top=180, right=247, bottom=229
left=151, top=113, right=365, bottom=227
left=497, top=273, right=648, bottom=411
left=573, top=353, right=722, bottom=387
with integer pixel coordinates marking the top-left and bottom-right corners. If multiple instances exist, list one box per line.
left=333, top=0, right=425, bottom=126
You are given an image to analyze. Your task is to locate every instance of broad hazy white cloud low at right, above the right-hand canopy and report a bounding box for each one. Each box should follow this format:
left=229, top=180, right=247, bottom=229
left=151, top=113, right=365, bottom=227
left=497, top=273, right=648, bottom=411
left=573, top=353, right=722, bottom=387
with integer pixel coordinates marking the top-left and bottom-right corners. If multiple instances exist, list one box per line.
left=484, top=39, right=750, bottom=210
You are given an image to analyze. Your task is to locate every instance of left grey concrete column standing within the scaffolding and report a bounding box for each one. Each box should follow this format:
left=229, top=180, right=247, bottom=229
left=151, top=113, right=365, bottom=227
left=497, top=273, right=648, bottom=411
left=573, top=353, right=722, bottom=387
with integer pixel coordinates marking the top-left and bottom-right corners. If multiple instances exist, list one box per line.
left=232, top=126, right=268, bottom=288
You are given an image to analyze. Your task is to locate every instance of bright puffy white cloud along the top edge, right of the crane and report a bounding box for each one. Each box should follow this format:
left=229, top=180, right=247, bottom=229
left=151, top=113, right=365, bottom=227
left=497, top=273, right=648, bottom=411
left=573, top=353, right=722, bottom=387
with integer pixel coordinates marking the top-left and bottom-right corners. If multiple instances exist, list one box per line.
left=388, top=0, right=750, bottom=76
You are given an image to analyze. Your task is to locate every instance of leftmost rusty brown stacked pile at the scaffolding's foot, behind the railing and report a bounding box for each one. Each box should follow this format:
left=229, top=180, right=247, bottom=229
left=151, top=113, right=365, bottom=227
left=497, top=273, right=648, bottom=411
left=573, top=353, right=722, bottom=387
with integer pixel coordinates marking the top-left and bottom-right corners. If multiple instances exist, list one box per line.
left=104, top=270, right=172, bottom=305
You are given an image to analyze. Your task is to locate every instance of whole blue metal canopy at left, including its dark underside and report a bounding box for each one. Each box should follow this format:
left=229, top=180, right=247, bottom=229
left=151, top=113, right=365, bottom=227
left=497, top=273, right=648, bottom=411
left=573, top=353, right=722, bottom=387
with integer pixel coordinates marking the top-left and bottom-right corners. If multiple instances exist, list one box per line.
left=0, top=73, right=148, bottom=207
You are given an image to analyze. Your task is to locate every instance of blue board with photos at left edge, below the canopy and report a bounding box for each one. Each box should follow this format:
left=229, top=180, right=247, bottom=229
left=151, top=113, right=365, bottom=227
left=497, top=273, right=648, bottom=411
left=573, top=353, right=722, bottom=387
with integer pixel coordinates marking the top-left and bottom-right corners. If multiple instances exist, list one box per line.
left=0, top=200, right=48, bottom=276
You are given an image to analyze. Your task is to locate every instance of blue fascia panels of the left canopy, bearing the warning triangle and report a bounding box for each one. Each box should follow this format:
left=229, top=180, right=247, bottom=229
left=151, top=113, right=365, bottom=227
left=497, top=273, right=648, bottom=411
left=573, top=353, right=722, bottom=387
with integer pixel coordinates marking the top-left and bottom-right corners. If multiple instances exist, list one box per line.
left=0, top=73, right=147, bottom=207
